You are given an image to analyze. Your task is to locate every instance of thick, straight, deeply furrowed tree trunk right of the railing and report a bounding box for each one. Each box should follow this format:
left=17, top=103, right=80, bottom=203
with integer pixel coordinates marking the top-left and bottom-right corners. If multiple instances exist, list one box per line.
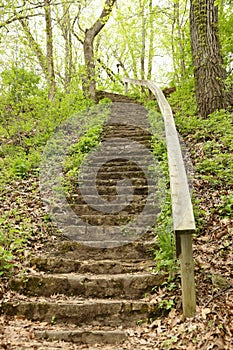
left=190, top=0, right=228, bottom=118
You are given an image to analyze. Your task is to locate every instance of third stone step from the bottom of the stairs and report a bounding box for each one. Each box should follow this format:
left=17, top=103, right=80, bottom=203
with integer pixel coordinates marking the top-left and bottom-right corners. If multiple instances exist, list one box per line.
left=9, top=272, right=164, bottom=300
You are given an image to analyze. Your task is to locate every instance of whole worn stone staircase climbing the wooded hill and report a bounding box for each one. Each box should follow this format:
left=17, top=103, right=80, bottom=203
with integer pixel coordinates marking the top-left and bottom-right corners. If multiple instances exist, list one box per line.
left=2, top=96, right=163, bottom=346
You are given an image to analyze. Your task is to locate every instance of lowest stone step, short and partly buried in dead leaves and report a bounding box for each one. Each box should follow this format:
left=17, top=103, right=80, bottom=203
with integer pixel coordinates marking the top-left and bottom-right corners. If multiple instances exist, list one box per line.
left=35, top=328, right=127, bottom=345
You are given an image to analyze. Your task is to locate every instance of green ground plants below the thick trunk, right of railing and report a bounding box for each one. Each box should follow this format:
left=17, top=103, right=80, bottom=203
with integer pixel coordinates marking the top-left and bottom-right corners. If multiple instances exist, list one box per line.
left=176, top=110, right=233, bottom=186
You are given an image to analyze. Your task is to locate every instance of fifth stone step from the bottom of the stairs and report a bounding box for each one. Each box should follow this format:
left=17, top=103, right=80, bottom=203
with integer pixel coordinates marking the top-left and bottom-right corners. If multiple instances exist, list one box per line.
left=47, top=240, right=157, bottom=262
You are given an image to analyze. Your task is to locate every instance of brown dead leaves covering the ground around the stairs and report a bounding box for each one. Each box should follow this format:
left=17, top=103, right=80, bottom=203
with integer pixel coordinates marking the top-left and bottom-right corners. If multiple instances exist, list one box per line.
left=0, top=102, right=233, bottom=350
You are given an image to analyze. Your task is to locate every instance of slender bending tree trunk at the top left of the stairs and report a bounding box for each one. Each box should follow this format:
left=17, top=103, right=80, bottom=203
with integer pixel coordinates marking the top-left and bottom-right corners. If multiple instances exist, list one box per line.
left=83, top=0, right=116, bottom=101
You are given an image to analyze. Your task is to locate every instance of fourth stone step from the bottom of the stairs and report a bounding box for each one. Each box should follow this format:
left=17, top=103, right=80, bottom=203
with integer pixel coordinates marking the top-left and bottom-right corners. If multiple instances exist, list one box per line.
left=30, top=256, right=156, bottom=275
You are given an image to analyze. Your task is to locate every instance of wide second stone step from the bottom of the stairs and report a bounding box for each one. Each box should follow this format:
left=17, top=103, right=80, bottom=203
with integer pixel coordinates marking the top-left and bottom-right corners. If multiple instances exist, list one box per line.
left=2, top=297, right=163, bottom=327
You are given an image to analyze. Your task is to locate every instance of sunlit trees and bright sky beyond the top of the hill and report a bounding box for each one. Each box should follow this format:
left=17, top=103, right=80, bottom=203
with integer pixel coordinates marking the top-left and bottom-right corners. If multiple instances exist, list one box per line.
left=0, top=0, right=233, bottom=117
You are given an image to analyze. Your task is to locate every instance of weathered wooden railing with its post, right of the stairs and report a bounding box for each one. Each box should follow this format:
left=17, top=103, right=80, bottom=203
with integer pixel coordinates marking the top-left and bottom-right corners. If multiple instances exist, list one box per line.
left=123, top=78, right=196, bottom=317
